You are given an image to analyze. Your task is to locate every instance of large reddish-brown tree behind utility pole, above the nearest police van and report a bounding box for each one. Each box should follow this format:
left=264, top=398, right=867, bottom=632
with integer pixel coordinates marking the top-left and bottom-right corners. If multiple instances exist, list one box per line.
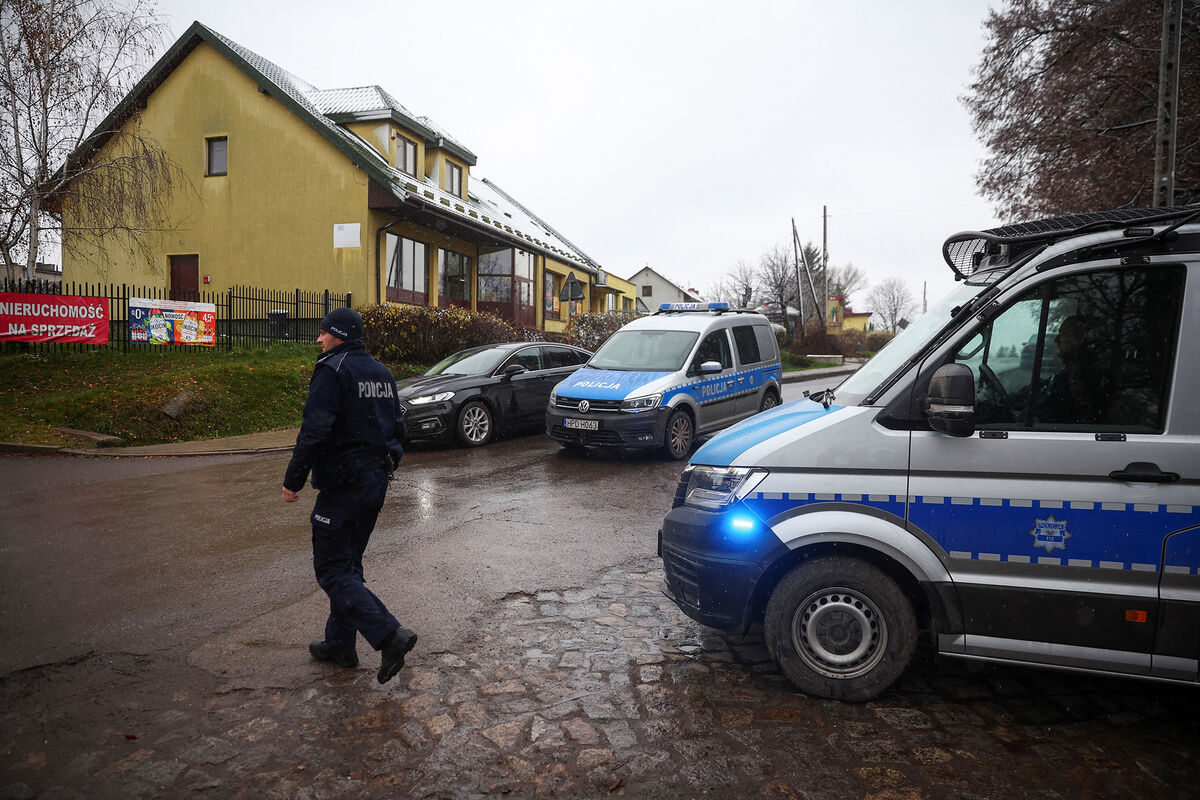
left=961, top=0, right=1200, bottom=219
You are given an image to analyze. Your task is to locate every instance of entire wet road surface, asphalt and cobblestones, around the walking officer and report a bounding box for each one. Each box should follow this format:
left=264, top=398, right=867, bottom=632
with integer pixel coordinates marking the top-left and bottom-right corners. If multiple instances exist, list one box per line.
left=0, top=376, right=1200, bottom=800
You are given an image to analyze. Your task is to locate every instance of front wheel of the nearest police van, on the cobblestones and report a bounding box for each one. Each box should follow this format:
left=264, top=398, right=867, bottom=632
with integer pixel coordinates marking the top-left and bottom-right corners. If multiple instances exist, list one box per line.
left=763, top=557, right=917, bottom=702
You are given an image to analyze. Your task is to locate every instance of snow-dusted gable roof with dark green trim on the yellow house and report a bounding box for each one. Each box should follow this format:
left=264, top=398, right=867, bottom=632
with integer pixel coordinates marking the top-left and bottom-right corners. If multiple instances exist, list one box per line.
left=56, top=22, right=600, bottom=275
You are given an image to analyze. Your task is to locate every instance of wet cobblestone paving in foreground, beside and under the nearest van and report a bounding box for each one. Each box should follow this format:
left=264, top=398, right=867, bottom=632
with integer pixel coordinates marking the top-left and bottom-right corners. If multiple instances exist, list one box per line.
left=0, top=559, right=1200, bottom=800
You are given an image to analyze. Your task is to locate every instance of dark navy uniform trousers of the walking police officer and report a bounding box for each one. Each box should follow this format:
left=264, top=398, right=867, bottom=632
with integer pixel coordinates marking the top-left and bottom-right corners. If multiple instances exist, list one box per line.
left=312, top=469, right=400, bottom=650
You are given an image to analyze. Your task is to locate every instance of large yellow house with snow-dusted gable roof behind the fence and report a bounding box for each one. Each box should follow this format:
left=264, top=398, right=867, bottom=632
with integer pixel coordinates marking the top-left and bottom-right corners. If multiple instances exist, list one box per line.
left=54, top=23, right=638, bottom=333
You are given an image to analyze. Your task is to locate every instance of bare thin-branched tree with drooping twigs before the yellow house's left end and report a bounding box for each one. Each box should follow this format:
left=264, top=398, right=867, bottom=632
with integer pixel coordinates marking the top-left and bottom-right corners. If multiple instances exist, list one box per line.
left=0, top=0, right=182, bottom=278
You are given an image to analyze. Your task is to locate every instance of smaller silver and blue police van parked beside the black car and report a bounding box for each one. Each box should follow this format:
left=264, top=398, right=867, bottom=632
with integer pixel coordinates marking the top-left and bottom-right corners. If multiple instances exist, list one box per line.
left=546, top=302, right=782, bottom=459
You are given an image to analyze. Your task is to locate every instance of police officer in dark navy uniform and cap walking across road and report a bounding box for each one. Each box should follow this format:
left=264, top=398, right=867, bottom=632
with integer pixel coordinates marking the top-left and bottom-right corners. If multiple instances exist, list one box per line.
left=283, top=308, right=416, bottom=684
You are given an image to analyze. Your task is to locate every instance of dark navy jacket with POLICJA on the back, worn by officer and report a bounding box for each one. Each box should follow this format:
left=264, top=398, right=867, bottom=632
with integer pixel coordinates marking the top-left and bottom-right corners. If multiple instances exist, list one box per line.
left=283, top=339, right=404, bottom=492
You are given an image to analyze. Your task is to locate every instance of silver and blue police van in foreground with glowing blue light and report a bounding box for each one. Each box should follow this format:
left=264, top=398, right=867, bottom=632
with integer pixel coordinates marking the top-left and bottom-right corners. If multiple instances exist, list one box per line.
left=659, top=206, right=1200, bottom=700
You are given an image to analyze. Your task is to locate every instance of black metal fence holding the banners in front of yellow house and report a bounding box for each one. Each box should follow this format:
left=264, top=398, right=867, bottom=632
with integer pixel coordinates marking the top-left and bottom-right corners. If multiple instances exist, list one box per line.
left=0, top=279, right=352, bottom=351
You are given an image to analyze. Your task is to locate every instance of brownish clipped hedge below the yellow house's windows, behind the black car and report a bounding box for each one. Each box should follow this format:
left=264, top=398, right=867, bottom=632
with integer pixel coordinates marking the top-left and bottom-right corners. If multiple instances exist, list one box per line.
left=358, top=305, right=522, bottom=365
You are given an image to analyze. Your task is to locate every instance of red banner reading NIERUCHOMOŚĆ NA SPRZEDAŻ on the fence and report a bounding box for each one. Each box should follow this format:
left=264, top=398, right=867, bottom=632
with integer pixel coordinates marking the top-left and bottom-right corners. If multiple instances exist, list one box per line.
left=0, top=291, right=108, bottom=344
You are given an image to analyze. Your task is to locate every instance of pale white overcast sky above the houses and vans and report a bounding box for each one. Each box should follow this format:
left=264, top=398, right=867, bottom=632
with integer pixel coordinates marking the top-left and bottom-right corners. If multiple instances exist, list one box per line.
left=150, top=0, right=997, bottom=309
